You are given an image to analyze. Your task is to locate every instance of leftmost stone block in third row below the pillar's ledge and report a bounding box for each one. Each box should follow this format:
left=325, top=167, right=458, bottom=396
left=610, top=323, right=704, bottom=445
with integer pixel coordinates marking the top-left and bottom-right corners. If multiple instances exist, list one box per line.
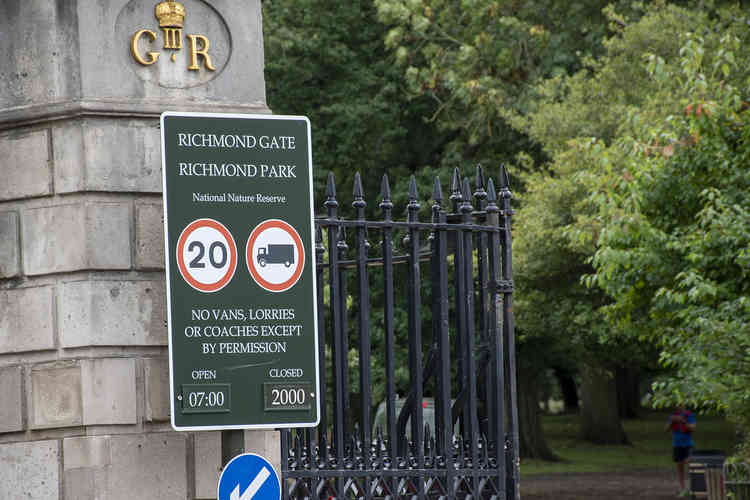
left=0, top=286, right=55, bottom=354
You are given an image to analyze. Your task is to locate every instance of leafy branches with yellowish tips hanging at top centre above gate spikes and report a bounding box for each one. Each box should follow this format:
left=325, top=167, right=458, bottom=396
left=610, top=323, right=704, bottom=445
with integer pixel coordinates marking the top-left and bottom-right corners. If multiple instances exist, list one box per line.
left=375, top=0, right=652, bottom=170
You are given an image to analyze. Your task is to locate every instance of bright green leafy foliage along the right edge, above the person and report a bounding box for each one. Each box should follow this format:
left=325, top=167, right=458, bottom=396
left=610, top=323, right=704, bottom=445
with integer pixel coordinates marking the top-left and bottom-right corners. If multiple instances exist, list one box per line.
left=588, top=6, right=750, bottom=446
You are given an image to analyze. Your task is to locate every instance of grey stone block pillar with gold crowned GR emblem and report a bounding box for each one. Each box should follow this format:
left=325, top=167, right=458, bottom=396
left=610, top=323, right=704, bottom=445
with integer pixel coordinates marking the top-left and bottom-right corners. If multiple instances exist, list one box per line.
left=0, top=0, right=278, bottom=500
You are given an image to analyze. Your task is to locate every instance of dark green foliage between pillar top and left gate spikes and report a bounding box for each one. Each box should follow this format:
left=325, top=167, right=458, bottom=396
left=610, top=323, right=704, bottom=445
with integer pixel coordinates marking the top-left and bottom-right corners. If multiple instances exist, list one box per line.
left=263, top=0, right=444, bottom=208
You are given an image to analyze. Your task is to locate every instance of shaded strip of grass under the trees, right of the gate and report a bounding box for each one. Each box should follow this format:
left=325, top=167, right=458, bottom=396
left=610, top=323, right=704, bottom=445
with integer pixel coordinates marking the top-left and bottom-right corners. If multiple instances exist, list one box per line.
left=521, top=412, right=735, bottom=476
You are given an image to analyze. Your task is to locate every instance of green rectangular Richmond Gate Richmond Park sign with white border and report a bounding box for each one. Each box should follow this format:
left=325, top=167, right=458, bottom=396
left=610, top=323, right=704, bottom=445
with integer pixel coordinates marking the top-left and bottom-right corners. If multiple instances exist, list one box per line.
left=161, top=112, right=320, bottom=431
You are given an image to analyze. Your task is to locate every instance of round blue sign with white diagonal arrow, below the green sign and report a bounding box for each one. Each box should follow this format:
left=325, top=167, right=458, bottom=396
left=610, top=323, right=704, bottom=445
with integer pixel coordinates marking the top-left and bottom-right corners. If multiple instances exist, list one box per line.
left=217, top=453, right=281, bottom=500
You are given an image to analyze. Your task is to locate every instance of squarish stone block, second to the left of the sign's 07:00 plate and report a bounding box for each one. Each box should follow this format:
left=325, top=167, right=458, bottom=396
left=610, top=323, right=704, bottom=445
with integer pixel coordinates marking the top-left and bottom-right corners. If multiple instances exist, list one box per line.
left=81, top=358, right=137, bottom=425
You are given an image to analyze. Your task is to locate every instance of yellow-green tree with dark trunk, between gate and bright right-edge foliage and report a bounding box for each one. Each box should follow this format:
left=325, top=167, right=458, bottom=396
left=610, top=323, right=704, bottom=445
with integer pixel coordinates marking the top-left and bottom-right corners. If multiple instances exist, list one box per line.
left=514, top=6, right=724, bottom=443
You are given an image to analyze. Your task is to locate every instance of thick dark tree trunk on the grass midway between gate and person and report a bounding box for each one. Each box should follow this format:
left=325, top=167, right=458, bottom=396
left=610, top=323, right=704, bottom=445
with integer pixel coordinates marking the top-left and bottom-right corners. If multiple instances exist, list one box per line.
left=581, top=361, right=630, bottom=444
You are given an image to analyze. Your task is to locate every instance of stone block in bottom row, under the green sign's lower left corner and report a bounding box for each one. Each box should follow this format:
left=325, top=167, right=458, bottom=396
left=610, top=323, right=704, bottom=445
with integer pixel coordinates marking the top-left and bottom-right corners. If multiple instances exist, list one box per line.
left=106, top=432, right=188, bottom=500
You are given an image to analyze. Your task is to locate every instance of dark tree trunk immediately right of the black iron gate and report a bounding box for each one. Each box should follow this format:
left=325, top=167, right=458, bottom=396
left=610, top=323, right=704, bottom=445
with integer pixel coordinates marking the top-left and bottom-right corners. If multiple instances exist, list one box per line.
left=518, top=367, right=559, bottom=461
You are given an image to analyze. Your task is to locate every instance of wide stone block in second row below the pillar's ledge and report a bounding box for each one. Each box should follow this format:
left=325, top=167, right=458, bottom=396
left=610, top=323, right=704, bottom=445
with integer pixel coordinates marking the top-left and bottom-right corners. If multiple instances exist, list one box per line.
left=22, top=203, right=130, bottom=275
